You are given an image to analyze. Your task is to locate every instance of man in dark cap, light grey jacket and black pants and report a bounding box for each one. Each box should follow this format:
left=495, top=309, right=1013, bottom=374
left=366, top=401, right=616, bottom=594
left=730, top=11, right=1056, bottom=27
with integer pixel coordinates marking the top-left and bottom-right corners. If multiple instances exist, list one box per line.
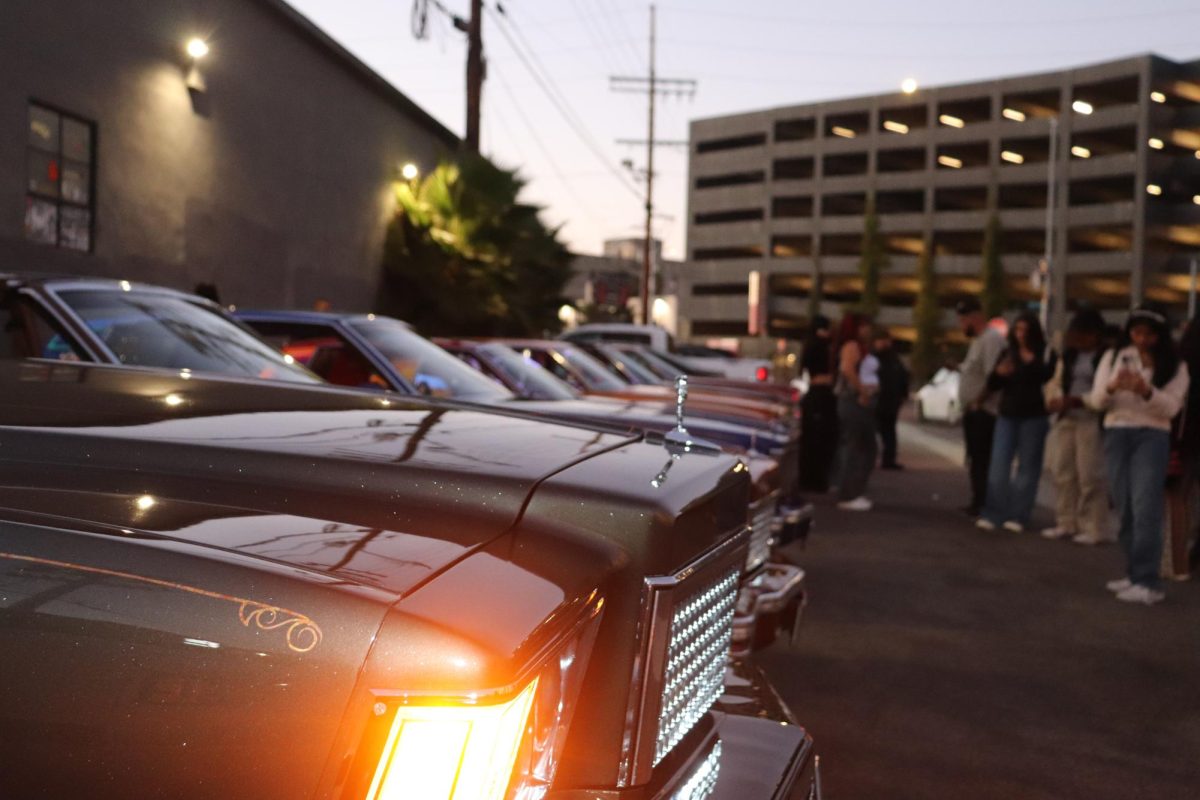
left=954, top=297, right=1004, bottom=517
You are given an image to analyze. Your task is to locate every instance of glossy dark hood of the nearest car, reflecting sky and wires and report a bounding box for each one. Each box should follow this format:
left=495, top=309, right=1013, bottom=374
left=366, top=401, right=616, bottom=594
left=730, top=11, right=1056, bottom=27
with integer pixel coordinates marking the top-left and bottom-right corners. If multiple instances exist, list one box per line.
left=0, top=362, right=636, bottom=594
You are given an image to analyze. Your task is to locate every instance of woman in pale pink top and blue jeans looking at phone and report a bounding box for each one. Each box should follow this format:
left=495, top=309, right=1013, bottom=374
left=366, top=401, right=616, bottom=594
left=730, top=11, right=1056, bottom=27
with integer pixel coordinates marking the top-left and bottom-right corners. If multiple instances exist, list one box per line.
left=1092, top=306, right=1188, bottom=606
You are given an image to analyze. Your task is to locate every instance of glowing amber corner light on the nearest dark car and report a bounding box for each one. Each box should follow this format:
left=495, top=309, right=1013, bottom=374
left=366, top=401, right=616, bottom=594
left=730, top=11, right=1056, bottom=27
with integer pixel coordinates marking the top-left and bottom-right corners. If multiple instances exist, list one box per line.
left=367, top=679, right=538, bottom=800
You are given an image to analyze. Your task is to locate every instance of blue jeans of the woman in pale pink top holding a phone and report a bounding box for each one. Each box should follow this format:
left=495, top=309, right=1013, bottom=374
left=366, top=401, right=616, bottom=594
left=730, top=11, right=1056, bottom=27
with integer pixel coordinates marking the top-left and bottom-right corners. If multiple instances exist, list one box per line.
left=1104, top=428, right=1171, bottom=590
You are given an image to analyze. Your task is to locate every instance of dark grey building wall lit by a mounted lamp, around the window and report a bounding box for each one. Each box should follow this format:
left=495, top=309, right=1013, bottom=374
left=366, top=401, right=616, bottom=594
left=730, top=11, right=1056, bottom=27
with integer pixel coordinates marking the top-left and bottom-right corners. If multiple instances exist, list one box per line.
left=0, top=0, right=454, bottom=308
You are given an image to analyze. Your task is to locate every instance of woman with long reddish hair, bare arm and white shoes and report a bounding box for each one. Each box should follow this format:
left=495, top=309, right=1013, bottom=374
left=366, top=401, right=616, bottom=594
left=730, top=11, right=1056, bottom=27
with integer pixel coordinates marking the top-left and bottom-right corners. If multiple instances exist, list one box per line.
left=836, top=313, right=880, bottom=511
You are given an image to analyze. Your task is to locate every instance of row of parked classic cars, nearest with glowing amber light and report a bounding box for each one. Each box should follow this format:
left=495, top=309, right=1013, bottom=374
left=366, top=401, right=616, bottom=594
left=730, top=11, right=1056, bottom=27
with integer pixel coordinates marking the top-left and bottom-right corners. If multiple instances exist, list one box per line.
left=0, top=275, right=820, bottom=800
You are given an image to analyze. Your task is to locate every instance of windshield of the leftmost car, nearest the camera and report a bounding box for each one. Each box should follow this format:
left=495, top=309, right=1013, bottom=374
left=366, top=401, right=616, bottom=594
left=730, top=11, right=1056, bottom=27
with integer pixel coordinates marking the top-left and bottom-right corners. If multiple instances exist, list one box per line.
left=58, top=289, right=320, bottom=384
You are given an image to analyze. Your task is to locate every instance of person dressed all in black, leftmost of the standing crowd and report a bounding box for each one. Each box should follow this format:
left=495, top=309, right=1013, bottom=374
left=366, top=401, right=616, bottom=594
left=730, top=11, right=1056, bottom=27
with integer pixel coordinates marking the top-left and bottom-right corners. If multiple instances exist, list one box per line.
left=800, top=315, right=838, bottom=493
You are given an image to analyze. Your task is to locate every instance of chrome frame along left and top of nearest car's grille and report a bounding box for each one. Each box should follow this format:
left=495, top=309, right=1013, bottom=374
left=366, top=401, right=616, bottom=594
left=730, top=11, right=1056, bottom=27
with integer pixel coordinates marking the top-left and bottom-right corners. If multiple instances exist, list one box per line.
left=617, top=525, right=750, bottom=787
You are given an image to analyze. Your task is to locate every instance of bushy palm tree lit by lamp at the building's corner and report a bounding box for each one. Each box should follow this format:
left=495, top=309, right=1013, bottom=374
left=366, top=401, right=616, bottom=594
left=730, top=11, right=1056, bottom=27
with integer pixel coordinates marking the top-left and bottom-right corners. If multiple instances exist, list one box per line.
left=380, top=155, right=570, bottom=336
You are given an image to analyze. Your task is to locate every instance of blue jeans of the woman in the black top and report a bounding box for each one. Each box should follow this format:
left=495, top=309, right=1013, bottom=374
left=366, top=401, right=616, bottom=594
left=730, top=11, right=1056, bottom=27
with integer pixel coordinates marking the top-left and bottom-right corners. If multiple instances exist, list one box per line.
left=983, top=416, right=1050, bottom=525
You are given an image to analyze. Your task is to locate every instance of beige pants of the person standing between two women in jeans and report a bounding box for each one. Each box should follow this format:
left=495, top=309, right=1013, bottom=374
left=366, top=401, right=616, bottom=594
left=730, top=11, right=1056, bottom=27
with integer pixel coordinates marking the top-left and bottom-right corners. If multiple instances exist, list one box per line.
left=1050, top=411, right=1112, bottom=539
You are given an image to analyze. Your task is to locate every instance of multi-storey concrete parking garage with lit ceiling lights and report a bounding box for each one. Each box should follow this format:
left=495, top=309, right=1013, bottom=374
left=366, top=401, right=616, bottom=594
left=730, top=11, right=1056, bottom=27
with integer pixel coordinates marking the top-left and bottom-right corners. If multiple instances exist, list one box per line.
left=679, top=55, right=1200, bottom=337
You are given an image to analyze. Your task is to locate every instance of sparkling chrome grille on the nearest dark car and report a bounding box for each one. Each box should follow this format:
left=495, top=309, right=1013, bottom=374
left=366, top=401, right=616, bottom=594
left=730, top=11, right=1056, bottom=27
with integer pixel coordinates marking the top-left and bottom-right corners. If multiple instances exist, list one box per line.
left=654, top=569, right=740, bottom=765
